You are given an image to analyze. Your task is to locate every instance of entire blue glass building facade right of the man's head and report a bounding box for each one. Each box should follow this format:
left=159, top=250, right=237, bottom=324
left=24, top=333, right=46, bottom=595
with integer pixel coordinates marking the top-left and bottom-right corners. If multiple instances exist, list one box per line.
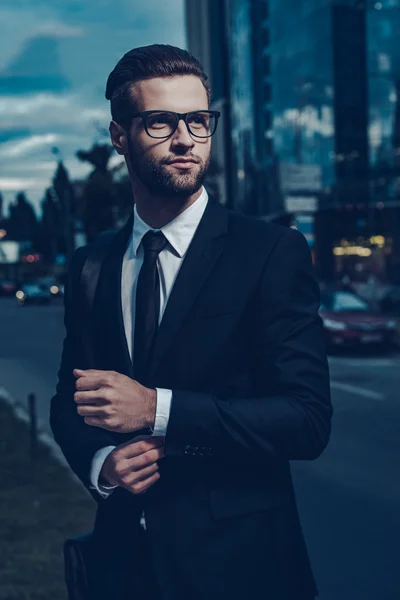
left=189, top=0, right=400, bottom=255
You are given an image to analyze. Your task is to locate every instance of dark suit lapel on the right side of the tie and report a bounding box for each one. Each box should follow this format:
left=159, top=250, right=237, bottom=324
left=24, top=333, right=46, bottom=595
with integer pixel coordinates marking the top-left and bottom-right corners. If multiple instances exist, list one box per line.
left=148, top=199, right=228, bottom=380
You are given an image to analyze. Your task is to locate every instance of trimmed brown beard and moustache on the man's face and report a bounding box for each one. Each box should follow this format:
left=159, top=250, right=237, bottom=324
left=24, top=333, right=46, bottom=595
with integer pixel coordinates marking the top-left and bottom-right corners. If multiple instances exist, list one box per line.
left=128, top=139, right=210, bottom=199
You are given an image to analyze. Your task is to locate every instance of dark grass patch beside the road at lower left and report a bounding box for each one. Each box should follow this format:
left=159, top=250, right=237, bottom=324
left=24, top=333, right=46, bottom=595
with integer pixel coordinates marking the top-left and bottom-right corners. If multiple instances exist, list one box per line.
left=0, top=400, right=95, bottom=600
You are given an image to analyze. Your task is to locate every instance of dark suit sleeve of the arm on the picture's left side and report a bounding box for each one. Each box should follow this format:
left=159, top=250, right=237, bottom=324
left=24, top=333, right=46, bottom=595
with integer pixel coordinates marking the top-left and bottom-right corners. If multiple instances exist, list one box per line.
left=50, top=248, right=116, bottom=500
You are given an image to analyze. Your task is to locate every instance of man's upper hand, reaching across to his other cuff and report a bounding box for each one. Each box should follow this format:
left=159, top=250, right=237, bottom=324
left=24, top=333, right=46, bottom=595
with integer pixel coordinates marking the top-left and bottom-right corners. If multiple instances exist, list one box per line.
left=73, top=369, right=157, bottom=433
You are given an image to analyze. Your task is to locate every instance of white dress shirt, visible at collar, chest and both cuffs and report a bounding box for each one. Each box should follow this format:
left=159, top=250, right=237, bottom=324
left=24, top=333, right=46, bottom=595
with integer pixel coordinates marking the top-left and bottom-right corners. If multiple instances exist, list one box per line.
left=90, top=187, right=208, bottom=498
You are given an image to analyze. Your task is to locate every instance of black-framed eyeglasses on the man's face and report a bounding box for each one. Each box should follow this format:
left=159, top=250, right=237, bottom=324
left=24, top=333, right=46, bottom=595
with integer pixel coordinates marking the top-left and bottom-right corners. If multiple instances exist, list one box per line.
left=131, top=110, right=221, bottom=139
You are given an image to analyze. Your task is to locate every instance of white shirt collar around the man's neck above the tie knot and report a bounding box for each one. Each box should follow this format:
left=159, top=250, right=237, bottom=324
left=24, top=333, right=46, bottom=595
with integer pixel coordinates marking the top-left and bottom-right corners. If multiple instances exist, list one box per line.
left=132, top=187, right=208, bottom=258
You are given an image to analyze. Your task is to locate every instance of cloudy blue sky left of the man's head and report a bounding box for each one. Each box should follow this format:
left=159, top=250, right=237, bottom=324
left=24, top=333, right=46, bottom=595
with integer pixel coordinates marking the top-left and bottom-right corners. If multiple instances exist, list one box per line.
left=0, top=0, right=186, bottom=216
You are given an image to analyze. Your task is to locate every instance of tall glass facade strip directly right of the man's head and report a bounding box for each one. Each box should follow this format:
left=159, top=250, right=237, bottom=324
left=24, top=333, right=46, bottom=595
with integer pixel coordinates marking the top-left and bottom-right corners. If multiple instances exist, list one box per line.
left=185, top=0, right=272, bottom=215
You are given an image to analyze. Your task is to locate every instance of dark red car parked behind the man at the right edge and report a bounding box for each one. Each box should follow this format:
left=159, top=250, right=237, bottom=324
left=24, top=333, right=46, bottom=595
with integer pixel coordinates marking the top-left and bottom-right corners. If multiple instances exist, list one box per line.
left=320, top=289, right=396, bottom=348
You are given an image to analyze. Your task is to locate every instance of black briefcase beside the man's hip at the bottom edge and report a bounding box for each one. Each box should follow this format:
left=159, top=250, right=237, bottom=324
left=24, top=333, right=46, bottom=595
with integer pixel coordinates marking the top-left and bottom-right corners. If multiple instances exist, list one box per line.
left=64, top=532, right=94, bottom=600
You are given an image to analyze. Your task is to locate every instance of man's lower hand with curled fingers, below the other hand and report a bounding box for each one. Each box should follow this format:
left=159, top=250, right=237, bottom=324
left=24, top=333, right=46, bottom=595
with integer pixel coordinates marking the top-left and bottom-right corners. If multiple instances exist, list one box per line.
left=99, top=437, right=164, bottom=494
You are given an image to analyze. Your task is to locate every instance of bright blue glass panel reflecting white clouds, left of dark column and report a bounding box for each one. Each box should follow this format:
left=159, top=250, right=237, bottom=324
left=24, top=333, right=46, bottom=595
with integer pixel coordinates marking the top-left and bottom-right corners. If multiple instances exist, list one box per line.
left=270, top=0, right=335, bottom=187
